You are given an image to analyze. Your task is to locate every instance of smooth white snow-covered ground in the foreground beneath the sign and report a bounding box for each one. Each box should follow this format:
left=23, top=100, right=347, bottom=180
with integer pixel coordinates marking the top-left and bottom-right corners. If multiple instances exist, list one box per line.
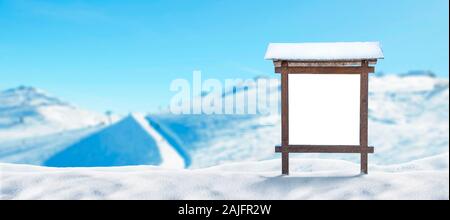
left=0, top=154, right=449, bottom=200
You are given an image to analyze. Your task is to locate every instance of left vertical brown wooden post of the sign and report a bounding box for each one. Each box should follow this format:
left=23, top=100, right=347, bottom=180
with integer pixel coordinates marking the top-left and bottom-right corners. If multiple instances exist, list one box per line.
left=281, top=61, right=289, bottom=175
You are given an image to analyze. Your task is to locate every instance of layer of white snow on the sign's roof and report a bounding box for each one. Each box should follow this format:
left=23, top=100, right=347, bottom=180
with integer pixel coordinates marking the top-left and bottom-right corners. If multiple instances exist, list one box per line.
left=265, top=42, right=384, bottom=61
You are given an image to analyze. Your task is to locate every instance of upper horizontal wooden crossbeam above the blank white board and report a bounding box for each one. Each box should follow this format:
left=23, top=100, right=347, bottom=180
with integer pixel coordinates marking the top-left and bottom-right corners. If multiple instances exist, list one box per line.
left=275, top=66, right=375, bottom=74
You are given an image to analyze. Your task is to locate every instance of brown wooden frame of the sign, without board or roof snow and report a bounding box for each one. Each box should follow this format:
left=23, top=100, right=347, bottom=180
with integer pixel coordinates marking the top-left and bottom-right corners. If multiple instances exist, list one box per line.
left=274, top=59, right=377, bottom=175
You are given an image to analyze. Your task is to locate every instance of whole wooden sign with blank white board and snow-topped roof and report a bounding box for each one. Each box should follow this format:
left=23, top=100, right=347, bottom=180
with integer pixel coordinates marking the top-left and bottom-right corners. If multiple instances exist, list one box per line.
left=266, top=42, right=384, bottom=175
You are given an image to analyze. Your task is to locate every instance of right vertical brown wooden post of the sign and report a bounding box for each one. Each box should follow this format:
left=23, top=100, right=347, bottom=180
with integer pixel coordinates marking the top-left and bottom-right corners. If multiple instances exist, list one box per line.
left=359, top=60, right=369, bottom=174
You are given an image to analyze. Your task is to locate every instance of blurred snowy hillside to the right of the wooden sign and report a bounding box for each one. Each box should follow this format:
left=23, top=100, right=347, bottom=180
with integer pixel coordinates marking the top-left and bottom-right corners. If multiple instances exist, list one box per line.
left=369, top=72, right=449, bottom=164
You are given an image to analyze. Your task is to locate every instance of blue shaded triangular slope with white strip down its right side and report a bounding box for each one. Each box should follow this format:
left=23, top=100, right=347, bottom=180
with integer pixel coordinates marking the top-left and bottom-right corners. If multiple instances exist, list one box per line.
left=44, top=114, right=187, bottom=168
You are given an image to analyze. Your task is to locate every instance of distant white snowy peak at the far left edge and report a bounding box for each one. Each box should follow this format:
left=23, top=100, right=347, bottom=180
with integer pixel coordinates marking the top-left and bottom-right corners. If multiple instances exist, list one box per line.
left=0, top=86, right=108, bottom=140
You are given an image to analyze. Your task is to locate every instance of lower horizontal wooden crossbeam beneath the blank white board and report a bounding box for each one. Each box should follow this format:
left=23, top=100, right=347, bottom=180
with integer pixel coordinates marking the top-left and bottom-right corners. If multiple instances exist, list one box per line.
left=275, top=145, right=375, bottom=154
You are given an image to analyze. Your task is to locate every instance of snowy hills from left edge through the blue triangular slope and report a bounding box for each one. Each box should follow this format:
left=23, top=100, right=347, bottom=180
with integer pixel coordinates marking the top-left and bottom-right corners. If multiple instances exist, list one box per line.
left=0, top=86, right=190, bottom=168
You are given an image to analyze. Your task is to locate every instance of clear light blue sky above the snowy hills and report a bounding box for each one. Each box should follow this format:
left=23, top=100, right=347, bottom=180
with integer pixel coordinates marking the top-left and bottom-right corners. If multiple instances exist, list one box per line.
left=0, top=0, right=449, bottom=113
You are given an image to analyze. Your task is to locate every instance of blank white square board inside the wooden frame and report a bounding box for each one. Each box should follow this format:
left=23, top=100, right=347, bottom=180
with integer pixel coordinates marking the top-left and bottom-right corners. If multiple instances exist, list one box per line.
left=289, top=74, right=360, bottom=145
